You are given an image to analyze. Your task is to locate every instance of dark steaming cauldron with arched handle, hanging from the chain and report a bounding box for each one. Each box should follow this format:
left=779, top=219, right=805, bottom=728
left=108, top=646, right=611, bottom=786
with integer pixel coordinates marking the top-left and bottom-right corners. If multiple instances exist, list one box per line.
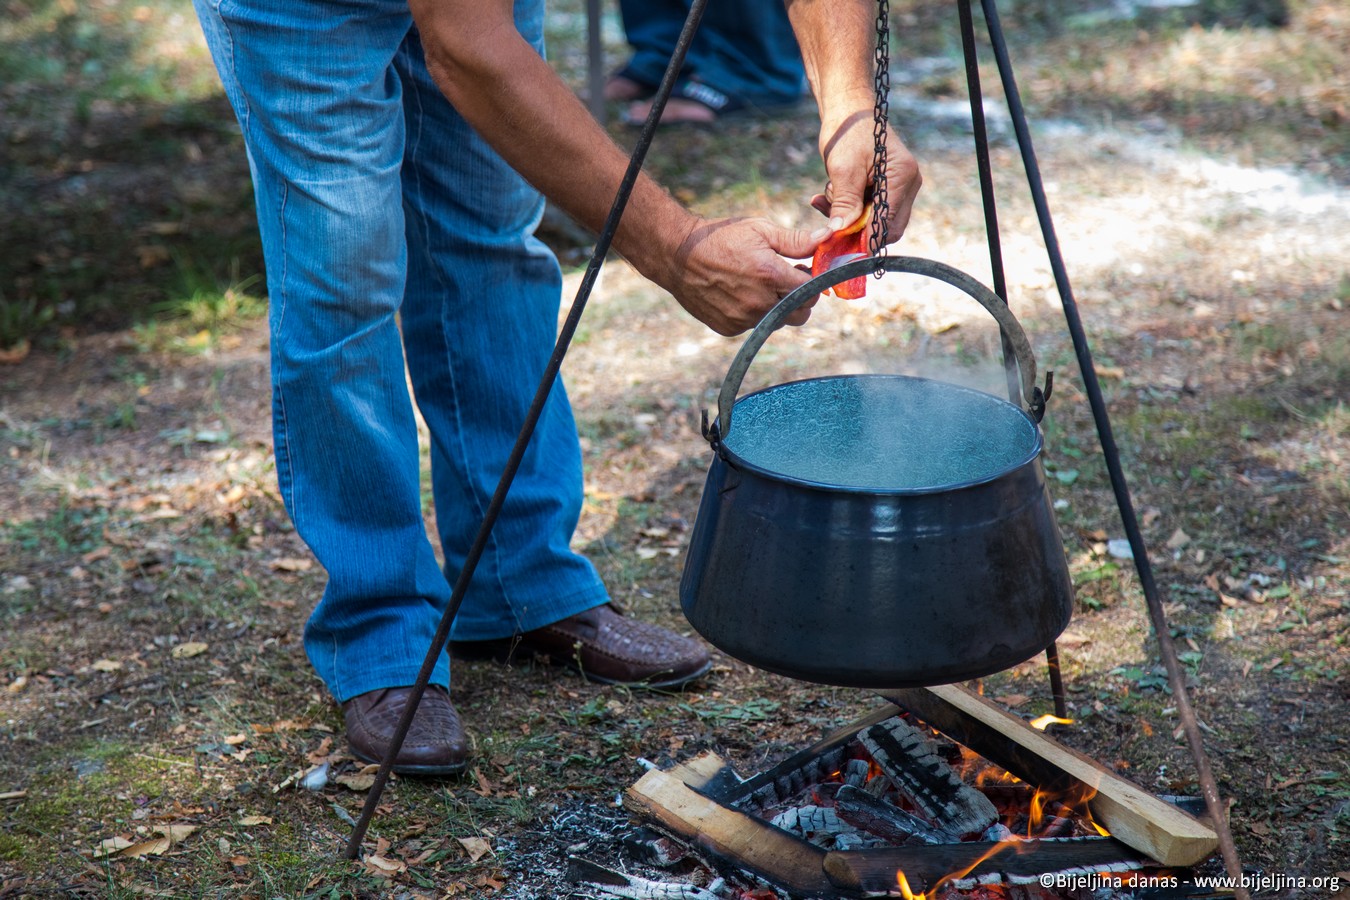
left=680, top=256, right=1073, bottom=688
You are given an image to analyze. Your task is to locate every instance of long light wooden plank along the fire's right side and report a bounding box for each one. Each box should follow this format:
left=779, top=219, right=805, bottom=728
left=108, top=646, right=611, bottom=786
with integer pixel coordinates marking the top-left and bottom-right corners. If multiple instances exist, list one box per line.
left=878, top=684, right=1219, bottom=866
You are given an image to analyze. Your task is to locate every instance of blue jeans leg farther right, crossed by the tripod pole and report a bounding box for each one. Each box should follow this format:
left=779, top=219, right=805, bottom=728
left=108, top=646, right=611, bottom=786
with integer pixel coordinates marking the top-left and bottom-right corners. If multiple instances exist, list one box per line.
left=394, top=19, right=608, bottom=640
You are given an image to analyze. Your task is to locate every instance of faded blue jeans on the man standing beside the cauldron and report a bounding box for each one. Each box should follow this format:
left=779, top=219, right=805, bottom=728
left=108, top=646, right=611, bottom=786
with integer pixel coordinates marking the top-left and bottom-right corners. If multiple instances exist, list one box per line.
left=196, top=0, right=608, bottom=702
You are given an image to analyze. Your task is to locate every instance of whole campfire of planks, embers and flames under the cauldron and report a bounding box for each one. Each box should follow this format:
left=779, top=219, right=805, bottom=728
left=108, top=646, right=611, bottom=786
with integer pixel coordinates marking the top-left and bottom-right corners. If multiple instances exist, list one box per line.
left=571, top=685, right=1216, bottom=900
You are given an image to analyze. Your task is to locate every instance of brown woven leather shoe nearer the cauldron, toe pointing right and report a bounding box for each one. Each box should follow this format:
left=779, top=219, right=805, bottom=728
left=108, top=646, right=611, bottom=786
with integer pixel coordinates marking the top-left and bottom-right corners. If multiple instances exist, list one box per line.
left=450, top=604, right=713, bottom=688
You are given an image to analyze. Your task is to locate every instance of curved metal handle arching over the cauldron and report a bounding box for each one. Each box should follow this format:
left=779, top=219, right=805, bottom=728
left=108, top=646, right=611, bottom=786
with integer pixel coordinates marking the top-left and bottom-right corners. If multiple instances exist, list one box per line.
left=703, top=256, right=1049, bottom=444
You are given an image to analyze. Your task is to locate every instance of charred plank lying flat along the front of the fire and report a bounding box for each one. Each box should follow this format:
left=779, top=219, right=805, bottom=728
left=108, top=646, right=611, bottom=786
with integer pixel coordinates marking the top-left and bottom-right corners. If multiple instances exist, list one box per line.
left=824, top=838, right=1149, bottom=893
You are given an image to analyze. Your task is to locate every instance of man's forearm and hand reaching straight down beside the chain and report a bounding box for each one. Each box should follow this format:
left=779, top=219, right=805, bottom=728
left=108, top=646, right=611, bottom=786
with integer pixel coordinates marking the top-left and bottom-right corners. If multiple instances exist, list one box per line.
left=786, top=0, right=923, bottom=242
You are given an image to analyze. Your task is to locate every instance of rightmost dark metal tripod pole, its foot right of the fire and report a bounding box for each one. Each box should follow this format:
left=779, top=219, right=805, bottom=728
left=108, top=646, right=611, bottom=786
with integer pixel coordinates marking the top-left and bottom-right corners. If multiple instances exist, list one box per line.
left=980, top=0, right=1250, bottom=900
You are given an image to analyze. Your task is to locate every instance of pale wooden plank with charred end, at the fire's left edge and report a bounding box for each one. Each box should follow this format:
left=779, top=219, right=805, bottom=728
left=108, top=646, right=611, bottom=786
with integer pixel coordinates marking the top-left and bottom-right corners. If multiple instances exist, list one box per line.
left=628, top=769, right=838, bottom=897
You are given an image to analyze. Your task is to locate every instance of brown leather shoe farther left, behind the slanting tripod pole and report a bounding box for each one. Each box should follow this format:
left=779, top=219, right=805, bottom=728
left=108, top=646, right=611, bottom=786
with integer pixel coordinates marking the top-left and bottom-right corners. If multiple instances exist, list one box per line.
left=342, top=684, right=468, bottom=775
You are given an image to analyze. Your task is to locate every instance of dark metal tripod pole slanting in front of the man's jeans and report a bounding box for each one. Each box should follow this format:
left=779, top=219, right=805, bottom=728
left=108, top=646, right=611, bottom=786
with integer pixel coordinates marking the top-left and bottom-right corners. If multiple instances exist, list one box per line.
left=346, top=0, right=707, bottom=860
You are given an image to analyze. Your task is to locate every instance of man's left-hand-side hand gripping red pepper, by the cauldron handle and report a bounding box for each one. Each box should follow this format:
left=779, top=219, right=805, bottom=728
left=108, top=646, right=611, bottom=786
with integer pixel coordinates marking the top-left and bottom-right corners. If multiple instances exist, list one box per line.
left=663, top=219, right=829, bottom=335
